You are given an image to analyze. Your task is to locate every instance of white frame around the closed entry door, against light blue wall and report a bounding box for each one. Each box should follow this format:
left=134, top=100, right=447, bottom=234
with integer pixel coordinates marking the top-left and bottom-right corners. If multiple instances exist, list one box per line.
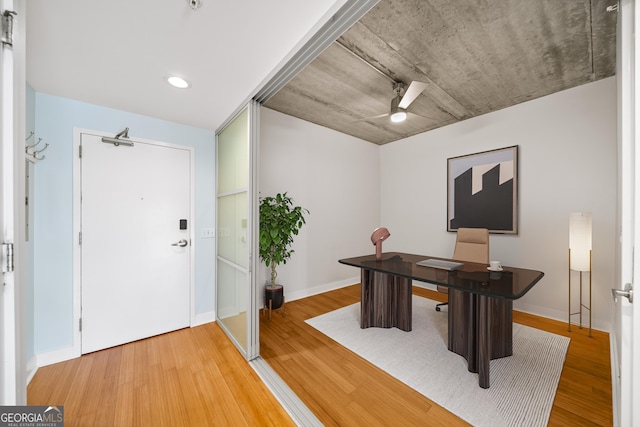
left=70, top=127, right=194, bottom=358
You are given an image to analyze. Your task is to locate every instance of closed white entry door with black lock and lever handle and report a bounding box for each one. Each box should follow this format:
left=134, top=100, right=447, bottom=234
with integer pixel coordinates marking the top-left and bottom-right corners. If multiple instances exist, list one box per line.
left=79, top=134, right=193, bottom=353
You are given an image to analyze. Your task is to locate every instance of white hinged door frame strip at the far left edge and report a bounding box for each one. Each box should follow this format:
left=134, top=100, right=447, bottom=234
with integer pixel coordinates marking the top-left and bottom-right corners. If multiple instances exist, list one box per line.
left=0, top=0, right=26, bottom=405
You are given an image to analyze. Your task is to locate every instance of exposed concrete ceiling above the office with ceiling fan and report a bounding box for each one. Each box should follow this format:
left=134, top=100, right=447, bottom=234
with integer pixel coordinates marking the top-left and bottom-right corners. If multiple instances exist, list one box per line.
left=265, top=0, right=617, bottom=144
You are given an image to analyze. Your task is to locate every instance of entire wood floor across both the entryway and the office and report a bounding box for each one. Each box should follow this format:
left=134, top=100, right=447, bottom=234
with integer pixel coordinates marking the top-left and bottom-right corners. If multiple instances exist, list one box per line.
left=28, top=285, right=613, bottom=426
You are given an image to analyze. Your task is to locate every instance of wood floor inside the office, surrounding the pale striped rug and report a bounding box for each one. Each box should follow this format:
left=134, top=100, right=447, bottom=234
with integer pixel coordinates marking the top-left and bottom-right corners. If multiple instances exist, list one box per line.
left=260, top=285, right=613, bottom=426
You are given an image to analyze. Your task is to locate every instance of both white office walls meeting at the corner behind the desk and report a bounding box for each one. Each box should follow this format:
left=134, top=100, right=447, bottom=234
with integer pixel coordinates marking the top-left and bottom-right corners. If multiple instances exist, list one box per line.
left=260, top=78, right=616, bottom=331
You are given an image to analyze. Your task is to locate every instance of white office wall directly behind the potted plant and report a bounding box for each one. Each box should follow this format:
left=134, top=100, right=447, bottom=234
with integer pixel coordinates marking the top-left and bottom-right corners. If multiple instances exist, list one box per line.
left=259, top=108, right=380, bottom=301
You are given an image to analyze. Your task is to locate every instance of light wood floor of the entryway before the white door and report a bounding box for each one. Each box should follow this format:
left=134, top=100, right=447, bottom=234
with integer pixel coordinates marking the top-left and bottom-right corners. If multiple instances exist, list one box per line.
left=27, top=323, right=294, bottom=427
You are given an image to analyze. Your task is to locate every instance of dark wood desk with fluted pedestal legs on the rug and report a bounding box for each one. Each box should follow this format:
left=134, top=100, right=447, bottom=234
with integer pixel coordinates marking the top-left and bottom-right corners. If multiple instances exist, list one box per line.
left=339, top=252, right=544, bottom=388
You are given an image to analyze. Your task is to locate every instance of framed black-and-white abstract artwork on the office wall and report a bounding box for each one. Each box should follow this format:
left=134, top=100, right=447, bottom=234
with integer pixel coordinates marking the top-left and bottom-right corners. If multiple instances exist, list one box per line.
left=447, top=145, right=518, bottom=234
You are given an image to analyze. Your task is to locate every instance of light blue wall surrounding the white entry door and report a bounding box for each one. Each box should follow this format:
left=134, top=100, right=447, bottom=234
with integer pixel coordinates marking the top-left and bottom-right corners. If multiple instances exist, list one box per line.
left=33, top=93, right=215, bottom=354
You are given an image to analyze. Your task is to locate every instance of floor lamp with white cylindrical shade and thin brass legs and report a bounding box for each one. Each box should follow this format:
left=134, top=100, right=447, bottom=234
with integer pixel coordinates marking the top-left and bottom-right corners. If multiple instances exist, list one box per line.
left=568, top=212, right=592, bottom=337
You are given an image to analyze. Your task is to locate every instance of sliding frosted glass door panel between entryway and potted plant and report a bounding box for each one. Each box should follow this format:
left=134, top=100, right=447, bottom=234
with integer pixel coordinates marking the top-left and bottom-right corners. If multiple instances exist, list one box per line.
left=216, top=102, right=259, bottom=360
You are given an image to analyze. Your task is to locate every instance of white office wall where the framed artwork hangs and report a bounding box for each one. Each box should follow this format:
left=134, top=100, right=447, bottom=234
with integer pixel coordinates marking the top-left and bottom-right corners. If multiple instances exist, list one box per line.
left=380, top=78, right=617, bottom=331
